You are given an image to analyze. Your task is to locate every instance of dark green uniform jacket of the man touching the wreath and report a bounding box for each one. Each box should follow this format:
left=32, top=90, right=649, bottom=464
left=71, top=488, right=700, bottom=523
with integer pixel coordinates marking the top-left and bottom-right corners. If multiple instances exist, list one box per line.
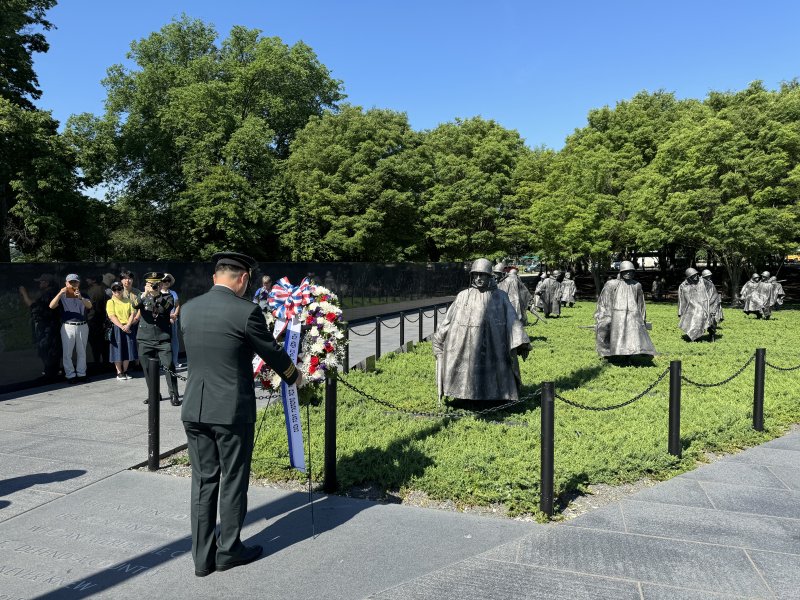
left=181, top=285, right=297, bottom=425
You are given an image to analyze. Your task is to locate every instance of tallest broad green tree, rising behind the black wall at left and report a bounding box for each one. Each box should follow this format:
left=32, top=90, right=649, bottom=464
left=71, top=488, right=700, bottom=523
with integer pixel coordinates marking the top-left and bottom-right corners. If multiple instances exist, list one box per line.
left=68, top=16, right=343, bottom=258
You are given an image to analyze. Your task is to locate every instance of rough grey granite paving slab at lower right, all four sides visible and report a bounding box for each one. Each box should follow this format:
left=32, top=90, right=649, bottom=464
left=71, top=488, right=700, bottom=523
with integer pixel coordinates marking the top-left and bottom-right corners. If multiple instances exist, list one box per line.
left=483, top=526, right=769, bottom=595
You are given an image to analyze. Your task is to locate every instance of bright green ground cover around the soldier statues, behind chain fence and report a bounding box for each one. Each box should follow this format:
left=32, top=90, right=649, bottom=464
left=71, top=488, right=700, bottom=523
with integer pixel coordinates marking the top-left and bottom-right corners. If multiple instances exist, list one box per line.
left=253, top=302, right=800, bottom=517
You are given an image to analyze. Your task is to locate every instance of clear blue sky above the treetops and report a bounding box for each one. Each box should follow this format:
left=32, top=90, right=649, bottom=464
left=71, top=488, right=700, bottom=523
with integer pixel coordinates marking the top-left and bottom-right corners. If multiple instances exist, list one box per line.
left=35, top=0, right=800, bottom=149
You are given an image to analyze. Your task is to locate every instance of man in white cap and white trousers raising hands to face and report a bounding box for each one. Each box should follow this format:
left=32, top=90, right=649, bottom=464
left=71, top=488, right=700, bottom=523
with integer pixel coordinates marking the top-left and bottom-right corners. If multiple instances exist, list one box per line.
left=50, top=273, right=92, bottom=383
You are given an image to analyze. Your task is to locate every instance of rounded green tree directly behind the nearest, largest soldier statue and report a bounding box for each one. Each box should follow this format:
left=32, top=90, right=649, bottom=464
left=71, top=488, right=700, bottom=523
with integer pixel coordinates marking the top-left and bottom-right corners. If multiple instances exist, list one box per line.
left=419, top=117, right=526, bottom=261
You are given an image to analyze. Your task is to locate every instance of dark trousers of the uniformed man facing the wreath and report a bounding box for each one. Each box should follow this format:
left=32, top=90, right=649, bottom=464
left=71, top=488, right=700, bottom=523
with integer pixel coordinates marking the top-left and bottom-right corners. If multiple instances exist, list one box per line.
left=183, top=421, right=255, bottom=571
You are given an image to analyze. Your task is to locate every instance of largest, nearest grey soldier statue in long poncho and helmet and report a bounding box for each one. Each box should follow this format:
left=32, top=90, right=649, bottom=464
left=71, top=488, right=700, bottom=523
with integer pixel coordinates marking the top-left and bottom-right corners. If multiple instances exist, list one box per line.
left=433, top=258, right=531, bottom=400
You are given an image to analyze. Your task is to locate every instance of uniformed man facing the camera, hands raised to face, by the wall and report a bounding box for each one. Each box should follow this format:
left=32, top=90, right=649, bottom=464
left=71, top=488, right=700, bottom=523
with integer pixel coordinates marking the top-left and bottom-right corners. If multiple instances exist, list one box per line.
left=131, top=272, right=181, bottom=406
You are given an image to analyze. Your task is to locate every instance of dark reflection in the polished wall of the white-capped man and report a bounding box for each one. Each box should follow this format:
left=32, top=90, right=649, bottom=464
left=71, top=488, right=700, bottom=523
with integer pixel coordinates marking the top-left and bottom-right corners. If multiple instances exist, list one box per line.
left=19, top=273, right=61, bottom=379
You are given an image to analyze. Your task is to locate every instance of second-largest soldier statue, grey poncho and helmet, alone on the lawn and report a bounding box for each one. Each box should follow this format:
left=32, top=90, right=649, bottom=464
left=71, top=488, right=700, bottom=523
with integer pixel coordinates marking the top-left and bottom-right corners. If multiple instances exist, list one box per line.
left=594, top=260, right=656, bottom=358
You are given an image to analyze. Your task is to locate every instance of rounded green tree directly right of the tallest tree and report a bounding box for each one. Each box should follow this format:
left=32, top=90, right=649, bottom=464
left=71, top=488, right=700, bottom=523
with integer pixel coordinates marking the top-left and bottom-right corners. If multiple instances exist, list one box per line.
left=282, top=106, right=426, bottom=261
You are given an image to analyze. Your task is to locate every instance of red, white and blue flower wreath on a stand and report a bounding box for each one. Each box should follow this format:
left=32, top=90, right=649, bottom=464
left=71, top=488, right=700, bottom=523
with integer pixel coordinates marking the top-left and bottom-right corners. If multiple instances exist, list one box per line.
left=255, top=277, right=346, bottom=390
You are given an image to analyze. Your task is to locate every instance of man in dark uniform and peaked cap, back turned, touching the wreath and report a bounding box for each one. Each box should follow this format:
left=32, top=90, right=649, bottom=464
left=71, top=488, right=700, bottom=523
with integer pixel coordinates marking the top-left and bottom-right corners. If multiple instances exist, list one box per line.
left=181, top=252, right=302, bottom=577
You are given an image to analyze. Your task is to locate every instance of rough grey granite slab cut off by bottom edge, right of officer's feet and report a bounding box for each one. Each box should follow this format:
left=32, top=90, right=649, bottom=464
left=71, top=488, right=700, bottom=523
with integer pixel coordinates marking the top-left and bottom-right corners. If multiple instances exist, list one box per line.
left=370, top=558, right=641, bottom=600
